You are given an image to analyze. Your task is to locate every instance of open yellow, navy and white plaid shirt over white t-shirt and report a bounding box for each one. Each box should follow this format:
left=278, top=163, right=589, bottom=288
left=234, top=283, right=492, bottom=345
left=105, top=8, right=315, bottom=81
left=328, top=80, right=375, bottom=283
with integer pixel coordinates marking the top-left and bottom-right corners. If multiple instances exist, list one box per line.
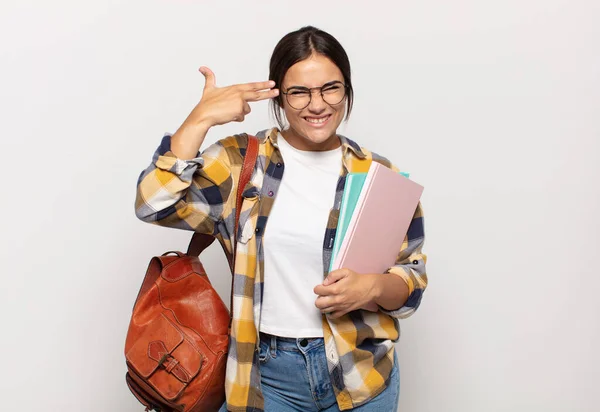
left=135, top=128, right=427, bottom=412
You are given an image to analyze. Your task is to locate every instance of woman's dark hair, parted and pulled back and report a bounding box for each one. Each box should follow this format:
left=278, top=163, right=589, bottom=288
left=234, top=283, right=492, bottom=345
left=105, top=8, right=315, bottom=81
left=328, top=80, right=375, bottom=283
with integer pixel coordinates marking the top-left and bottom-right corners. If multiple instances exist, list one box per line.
left=269, top=26, right=354, bottom=128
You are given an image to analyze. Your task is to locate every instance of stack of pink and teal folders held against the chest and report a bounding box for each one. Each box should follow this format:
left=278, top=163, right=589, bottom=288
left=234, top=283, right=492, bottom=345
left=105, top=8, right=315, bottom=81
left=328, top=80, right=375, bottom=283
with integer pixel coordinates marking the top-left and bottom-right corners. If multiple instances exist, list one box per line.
left=330, top=162, right=423, bottom=273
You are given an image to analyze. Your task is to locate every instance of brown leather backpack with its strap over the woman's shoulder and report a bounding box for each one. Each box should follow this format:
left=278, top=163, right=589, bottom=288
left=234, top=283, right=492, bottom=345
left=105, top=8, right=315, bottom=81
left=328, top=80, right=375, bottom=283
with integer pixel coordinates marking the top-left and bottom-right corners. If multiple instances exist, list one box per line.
left=125, top=136, right=258, bottom=412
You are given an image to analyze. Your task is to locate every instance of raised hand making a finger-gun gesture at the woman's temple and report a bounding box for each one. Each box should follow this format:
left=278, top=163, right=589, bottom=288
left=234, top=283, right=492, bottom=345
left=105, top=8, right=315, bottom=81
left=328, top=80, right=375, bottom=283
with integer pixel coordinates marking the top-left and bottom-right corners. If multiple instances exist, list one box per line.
left=186, top=67, right=279, bottom=128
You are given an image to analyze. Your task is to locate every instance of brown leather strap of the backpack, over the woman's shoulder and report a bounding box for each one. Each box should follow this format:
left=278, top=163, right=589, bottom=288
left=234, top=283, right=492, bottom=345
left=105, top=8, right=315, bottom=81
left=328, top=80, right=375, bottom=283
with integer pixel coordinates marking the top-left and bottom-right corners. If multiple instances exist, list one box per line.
left=187, top=135, right=258, bottom=273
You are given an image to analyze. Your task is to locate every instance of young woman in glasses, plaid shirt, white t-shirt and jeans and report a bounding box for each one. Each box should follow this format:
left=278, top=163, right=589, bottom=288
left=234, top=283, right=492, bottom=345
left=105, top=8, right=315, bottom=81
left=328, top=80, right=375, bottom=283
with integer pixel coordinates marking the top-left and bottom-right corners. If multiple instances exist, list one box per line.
left=136, top=27, right=427, bottom=412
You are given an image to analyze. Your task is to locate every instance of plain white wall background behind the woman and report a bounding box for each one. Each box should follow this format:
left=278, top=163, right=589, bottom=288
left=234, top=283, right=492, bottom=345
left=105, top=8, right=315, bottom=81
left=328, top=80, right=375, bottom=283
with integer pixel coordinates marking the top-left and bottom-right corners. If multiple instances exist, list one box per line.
left=0, top=0, right=600, bottom=412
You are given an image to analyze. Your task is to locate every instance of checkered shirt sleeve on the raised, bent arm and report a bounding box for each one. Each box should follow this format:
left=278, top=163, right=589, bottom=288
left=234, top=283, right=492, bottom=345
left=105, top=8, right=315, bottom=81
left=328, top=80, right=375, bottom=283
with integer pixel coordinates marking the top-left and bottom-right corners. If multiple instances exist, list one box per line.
left=135, top=135, right=233, bottom=234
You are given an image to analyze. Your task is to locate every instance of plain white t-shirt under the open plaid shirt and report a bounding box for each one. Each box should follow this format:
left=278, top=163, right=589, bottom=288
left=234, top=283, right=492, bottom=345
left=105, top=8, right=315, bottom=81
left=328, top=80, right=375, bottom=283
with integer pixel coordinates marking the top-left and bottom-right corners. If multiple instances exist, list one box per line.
left=260, top=134, right=342, bottom=338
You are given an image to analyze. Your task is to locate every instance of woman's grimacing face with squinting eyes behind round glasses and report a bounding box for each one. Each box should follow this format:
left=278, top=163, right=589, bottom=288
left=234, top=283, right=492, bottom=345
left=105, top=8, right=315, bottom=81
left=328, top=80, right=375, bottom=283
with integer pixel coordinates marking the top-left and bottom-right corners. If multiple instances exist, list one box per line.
left=281, top=54, right=346, bottom=151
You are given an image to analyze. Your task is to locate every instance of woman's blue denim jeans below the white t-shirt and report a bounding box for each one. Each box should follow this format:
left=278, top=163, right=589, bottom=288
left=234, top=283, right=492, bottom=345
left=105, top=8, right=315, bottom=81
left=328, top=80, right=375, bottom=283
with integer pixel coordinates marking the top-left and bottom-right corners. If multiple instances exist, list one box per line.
left=219, top=333, right=400, bottom=412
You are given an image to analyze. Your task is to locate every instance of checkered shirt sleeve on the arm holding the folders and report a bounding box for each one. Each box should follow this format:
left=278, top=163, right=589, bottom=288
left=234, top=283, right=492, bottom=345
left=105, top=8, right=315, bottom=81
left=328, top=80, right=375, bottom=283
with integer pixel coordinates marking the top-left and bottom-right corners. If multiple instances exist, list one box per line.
left=379, top=203, right=427, bottom=319
